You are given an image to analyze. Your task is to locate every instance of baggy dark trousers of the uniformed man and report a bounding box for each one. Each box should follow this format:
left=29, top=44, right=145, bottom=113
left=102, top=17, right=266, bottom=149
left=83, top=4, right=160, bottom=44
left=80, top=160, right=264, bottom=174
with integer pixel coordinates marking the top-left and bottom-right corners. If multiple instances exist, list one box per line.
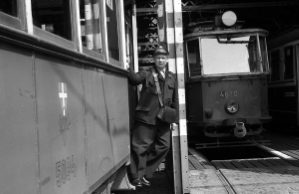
left=130, top=121, right=170, bottom=178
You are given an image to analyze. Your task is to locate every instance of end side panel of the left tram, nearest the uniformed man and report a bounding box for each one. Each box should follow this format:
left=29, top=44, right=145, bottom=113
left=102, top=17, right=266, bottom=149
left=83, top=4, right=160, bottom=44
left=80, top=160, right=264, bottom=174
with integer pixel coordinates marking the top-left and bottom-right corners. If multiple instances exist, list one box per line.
left=83, top=70, right=130, bottom=190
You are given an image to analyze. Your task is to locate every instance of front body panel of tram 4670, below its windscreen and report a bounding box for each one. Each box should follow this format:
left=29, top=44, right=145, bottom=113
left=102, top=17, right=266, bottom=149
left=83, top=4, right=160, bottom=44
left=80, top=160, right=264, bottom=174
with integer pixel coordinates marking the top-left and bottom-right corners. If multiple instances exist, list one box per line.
left=187, top=78, right=266, bottom=125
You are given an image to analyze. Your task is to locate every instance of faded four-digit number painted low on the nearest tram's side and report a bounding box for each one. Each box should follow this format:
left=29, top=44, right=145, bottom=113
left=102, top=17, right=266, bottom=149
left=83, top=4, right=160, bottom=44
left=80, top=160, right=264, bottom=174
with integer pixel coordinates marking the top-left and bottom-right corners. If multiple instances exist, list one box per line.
left=56, top=155, right=76, bottom=187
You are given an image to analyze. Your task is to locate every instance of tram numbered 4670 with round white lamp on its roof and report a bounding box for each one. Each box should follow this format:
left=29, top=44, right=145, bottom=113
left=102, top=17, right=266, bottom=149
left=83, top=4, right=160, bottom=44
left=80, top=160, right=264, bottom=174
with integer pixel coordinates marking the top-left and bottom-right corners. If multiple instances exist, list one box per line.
left=184, top=11, right=271, bottom=140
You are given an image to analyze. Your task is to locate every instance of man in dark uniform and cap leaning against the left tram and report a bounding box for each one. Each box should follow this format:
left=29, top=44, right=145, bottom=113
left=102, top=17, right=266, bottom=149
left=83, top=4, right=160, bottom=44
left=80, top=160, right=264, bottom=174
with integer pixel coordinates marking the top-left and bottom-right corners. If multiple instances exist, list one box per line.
left=129, top=46, right=179, bottom=187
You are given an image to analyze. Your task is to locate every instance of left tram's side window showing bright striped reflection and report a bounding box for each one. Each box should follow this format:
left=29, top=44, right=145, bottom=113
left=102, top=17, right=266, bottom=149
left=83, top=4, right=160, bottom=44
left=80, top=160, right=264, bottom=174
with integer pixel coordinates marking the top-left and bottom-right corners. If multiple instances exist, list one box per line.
left=80, top=0, right=103, bottom=53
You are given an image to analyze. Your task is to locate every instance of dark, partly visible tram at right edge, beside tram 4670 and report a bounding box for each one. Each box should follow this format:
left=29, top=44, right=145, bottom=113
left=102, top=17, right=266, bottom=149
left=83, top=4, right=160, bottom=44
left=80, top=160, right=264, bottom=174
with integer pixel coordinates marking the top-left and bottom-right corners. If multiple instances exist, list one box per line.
left=268, top=29, right=299, bottom=132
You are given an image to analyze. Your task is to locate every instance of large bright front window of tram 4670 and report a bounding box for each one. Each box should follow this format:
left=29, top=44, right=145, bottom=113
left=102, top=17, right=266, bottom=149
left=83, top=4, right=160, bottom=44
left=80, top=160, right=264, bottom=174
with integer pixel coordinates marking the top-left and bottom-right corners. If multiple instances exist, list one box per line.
left=201, top=36, right=260, bottom=75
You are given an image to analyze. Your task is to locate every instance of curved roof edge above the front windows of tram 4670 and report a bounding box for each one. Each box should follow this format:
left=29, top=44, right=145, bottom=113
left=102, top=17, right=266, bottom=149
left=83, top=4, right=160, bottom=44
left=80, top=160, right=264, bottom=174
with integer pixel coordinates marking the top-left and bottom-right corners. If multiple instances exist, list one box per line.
left=184, top=28, right=268, bottom=39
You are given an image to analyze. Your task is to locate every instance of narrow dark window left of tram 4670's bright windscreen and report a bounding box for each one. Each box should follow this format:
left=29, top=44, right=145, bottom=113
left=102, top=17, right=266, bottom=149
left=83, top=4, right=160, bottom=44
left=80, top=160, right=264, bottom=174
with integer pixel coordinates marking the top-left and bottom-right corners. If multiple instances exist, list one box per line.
left=187, top=39, right=201, bottom=76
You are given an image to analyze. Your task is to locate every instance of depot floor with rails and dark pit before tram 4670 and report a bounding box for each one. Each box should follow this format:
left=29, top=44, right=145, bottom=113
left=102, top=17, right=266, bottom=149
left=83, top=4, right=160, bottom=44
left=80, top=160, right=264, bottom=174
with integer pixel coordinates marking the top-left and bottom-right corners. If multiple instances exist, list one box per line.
left=189, top=145, right=299, bottom=194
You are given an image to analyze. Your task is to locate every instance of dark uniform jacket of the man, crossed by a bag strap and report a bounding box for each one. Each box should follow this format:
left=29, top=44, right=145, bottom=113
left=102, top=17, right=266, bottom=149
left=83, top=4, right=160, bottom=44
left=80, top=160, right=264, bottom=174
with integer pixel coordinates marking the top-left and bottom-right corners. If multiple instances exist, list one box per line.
left=129, top=67, right=179, bottom=125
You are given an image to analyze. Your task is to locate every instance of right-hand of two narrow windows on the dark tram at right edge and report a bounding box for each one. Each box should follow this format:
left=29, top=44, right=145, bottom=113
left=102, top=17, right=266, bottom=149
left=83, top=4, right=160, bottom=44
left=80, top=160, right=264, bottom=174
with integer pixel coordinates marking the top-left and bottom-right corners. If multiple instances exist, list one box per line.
left=284, top=46, right=294, bottom=79
